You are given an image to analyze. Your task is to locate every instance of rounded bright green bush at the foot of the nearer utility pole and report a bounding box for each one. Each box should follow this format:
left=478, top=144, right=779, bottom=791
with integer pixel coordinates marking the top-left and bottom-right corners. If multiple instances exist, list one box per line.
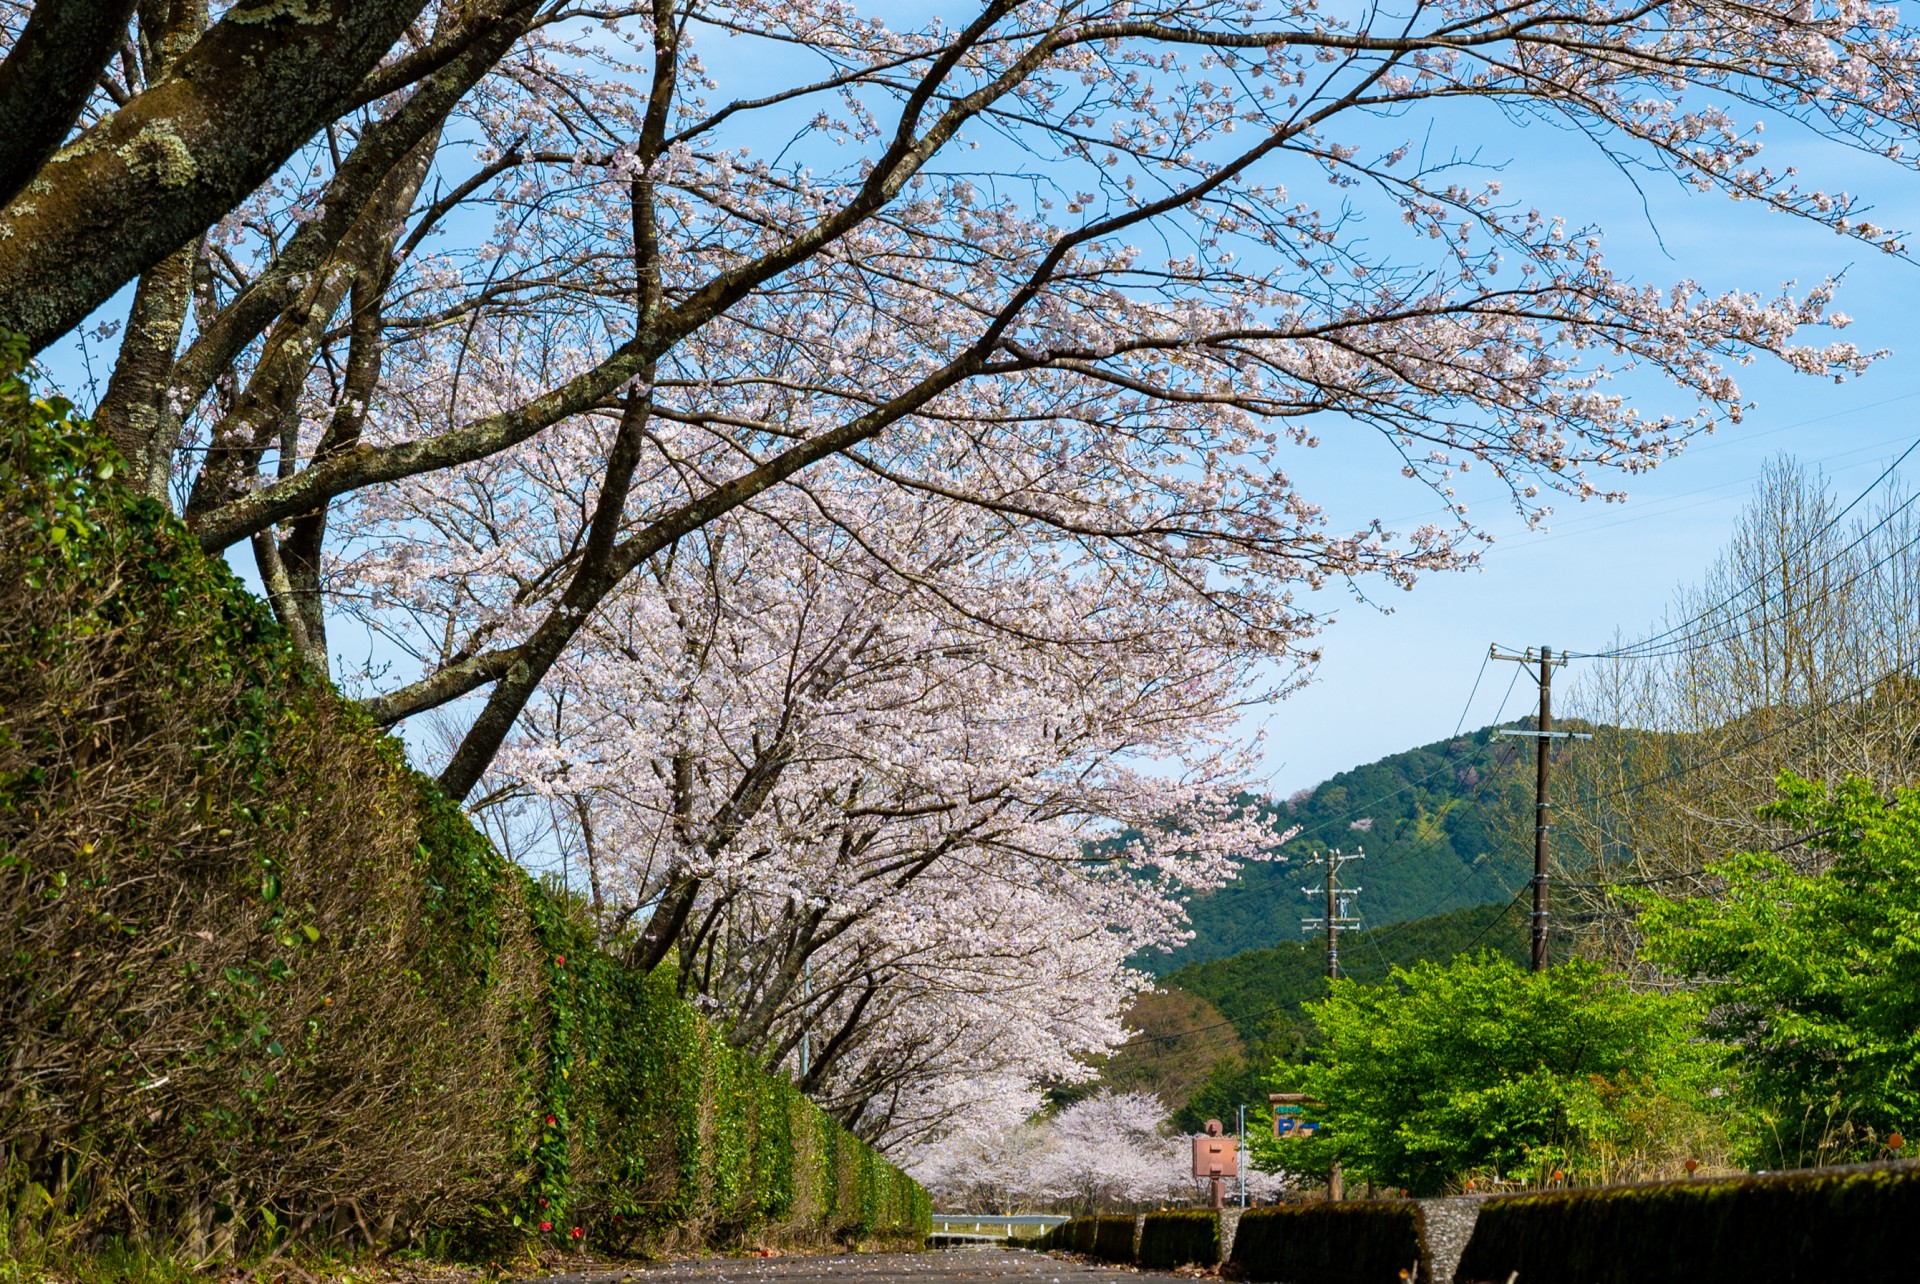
left=1256, top=954, right=1724, bottom=1194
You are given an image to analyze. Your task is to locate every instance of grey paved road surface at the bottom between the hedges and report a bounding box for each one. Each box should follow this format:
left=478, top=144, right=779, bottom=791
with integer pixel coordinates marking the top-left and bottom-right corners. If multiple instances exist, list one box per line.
left=538, top=1248, right=1192, bottom=1284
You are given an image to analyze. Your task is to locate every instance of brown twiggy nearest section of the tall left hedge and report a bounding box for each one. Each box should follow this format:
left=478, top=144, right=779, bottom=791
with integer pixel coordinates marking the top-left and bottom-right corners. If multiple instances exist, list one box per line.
left=0, top=337, right=538, bottom=1253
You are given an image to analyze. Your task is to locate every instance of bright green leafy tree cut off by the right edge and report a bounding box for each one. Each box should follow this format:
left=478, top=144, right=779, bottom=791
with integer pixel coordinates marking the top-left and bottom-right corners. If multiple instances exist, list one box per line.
left=1638, top=773, right=1920, bottom=1167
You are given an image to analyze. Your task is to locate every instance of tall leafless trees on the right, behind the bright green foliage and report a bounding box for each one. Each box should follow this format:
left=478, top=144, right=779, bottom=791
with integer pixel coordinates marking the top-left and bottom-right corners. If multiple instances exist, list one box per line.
left=1563, top=459, right=1920, bottom=962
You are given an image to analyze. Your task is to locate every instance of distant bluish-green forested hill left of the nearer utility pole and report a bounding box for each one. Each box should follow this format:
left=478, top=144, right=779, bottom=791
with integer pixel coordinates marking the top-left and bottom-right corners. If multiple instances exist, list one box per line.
left=1137, top=722, right=1574, bottom=975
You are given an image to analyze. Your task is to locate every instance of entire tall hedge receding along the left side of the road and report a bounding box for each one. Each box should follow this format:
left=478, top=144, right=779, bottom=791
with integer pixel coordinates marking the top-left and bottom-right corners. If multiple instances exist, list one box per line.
left=0, top=347, right=931, bottom=1257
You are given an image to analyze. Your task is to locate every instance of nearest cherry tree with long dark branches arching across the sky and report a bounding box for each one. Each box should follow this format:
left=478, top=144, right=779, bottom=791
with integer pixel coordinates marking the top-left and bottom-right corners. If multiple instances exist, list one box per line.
left=11, top=0, right=1920, bottom=817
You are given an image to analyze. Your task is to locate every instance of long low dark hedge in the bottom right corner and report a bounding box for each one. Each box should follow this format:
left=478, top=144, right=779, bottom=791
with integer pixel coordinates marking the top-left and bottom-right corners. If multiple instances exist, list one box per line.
left=1453, top=1161, right=1920, bottom=1284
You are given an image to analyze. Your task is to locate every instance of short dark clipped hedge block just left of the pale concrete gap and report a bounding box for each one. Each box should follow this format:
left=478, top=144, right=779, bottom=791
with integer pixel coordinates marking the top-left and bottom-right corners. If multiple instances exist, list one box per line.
left=1233, top=1200, right=1428, bottom=1284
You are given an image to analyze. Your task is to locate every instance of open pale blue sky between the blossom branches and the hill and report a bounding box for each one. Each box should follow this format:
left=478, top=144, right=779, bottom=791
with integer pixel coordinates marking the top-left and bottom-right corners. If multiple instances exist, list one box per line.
left=1248, top=112, right=1920, bottom=795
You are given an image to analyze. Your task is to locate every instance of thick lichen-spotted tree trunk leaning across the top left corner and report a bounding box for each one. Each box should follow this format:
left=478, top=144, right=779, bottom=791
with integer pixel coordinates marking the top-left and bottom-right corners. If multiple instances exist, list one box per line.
left=0, top=0, right=538, bottom=349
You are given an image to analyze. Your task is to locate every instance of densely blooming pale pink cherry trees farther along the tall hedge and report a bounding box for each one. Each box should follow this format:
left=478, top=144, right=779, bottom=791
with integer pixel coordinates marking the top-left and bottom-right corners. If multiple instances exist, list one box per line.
left=397, top=435, right=1284, bottom=1144
